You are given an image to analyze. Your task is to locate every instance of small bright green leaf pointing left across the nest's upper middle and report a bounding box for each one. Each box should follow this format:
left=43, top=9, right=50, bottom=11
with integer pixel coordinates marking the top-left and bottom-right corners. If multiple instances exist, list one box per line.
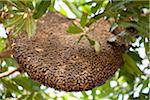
left=67, top=24, right=83, bottom=34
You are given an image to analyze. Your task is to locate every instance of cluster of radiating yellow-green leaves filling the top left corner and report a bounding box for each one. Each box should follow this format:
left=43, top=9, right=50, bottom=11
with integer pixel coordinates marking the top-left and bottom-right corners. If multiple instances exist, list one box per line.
left=0, top=0, right=50, bottom=37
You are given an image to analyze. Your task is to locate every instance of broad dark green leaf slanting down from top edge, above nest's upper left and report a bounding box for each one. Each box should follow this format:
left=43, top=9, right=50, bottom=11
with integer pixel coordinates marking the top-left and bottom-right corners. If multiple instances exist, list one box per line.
left=33, top=0, right=51, bottom=19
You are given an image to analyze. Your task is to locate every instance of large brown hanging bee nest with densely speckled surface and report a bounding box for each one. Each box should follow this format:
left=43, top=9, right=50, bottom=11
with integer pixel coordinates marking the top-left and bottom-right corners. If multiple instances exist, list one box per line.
left=13, top=13, right=125, bottom=91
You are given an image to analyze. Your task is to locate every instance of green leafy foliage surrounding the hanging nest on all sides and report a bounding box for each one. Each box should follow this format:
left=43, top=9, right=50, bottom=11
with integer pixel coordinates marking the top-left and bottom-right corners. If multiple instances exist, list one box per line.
left=0, top=0, right=150, bottom=100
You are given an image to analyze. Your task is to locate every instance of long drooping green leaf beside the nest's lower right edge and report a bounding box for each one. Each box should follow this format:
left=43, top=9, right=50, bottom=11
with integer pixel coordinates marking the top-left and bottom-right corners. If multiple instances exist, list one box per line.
left=123, top=53, right=143, bottom=75
